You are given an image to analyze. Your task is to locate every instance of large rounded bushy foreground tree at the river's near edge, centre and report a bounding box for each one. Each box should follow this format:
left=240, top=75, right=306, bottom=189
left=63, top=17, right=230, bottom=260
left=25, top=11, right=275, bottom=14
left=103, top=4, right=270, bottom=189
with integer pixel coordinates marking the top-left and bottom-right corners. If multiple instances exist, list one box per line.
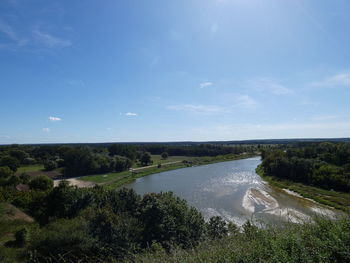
left=140, top=192, right=205, bottom=249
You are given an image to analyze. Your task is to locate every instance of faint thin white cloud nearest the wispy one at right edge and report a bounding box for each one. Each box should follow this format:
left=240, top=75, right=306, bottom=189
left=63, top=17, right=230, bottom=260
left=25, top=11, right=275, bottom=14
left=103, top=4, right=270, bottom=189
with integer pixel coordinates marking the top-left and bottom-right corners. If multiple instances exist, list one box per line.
left=249, top=78, right=293, bottom=95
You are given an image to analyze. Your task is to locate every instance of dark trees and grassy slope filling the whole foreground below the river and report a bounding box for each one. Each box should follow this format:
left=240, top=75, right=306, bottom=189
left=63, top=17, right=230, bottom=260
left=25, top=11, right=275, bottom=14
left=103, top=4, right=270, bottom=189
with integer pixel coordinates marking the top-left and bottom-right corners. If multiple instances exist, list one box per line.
left=0, top=181, right=350, bottom=262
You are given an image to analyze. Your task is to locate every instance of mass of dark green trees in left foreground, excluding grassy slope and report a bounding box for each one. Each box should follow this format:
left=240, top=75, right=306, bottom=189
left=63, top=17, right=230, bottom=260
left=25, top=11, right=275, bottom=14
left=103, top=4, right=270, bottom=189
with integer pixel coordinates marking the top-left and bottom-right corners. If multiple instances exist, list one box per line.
left=0, top=181, right=237, bottom=262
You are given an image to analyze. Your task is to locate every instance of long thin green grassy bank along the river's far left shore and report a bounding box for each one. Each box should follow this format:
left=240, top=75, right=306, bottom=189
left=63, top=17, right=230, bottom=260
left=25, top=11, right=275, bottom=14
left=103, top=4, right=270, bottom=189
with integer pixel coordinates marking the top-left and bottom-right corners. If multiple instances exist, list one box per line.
left=79, top=153, right=259, bottom=188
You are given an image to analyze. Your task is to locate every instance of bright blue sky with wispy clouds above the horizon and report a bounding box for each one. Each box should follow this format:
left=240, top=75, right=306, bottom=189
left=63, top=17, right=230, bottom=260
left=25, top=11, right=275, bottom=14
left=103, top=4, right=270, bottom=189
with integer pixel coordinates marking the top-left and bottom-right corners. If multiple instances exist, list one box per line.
left=0, top=0, right=350, bottom=143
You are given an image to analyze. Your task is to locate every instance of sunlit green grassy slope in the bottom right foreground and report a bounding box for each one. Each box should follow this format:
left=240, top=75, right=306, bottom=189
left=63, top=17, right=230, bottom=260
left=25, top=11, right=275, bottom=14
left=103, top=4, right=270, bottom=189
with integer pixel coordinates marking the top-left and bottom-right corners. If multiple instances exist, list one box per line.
left=127, top=218, right=350, bottom=263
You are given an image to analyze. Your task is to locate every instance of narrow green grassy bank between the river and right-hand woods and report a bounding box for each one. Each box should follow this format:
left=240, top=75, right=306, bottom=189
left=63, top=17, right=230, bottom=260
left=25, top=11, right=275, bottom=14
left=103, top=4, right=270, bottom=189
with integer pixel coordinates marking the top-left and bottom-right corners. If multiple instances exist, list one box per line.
left=256, top=165, right=350, bottom=214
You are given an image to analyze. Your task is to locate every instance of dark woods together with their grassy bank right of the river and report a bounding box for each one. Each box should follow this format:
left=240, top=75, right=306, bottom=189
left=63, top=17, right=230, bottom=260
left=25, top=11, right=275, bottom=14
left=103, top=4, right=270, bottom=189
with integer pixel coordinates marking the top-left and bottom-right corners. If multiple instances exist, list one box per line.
left=257, top=142, right=350, bottom=213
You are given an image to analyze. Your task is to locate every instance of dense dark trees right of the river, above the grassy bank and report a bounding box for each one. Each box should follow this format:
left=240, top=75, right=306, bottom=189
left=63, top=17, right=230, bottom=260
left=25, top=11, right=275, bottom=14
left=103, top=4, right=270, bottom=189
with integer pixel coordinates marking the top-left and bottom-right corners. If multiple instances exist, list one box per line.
left=262, top=142, right=350, bottom=192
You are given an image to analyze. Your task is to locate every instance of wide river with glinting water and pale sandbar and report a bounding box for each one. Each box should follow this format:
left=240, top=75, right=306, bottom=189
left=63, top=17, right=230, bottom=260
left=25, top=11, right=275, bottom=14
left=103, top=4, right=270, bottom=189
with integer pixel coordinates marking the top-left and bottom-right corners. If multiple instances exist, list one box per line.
left=126, top=157, right=336, bottom=225
